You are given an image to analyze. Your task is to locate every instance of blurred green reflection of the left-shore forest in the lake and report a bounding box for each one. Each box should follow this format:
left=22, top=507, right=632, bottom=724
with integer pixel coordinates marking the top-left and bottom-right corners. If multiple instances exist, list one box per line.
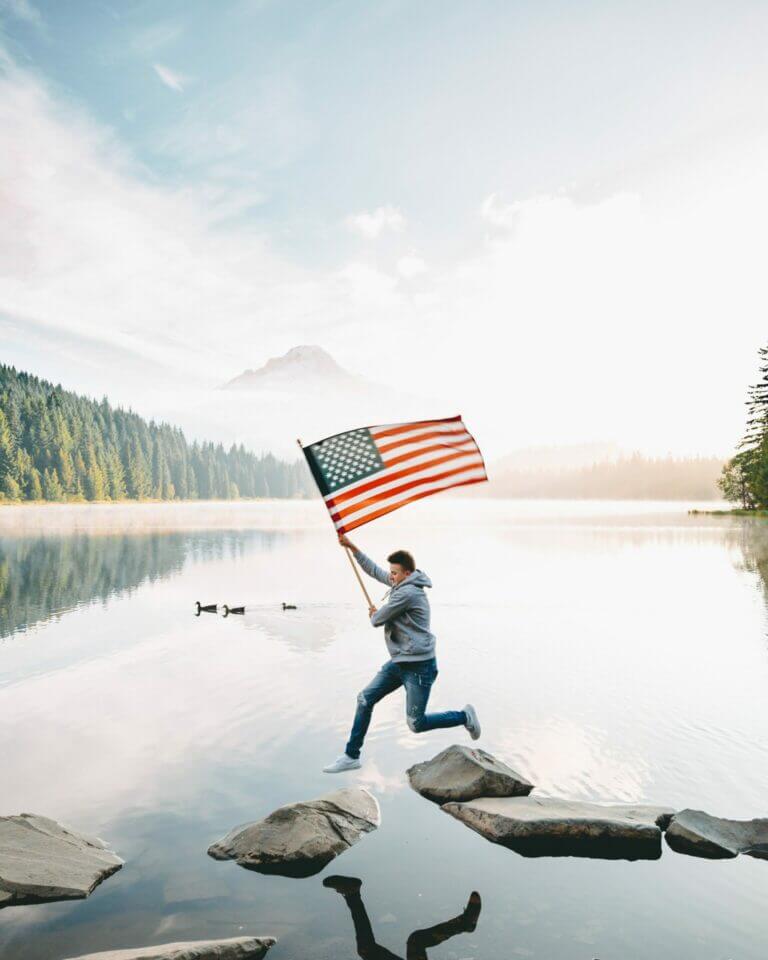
left=0, top=530, right=279, bottom=638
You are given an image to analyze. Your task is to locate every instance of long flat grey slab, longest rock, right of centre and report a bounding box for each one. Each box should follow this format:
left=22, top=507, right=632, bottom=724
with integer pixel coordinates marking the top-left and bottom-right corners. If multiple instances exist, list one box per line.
left=442, top=797, right=674, bottom=860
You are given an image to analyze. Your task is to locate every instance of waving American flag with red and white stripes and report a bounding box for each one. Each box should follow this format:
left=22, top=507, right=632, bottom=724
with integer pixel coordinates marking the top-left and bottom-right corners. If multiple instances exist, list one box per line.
left=302, top=417, right=488, bottom=533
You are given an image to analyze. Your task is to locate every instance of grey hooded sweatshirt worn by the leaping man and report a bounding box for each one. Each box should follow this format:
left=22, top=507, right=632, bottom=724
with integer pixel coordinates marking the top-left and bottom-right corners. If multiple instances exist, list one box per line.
left=355, top=550, right=435, bottom=663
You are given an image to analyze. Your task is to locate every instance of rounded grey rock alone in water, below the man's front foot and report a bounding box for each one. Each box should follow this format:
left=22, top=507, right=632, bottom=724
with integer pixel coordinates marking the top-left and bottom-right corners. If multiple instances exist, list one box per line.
left=208, top=787, right=381, bottom=877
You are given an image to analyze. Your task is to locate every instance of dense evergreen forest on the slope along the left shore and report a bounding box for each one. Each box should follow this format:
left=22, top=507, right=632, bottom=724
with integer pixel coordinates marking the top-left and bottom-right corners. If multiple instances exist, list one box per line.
left=0, top=365, right=315, bottom=500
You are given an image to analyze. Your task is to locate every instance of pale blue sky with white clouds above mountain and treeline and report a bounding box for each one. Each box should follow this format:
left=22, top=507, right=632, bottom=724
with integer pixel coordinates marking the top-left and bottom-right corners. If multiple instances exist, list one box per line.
left=0, top=0, right=768, bottom=455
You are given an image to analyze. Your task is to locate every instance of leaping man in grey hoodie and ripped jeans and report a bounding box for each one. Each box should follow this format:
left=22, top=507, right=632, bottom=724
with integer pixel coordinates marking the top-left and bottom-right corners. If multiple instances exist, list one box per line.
left=323, top=535, right=480, bottom=773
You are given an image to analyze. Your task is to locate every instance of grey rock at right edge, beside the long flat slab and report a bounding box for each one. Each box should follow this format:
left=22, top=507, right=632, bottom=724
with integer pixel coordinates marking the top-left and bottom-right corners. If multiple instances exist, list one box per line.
left=666, top=810, right=768, bottom=860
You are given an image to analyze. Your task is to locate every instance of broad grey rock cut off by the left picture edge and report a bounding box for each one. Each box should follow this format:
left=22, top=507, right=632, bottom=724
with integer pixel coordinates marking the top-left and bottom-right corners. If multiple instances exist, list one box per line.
left=0, top=813, right=123, bottom=907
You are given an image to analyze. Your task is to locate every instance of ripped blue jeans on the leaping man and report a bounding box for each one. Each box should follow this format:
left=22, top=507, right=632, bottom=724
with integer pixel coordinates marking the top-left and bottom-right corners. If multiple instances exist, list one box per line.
left=345, top=657, right=467, bottom=758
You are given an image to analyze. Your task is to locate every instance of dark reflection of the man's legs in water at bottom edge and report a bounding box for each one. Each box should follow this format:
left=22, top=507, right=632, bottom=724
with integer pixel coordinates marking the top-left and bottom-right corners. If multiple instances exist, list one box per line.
left=323, top=877, right=480, bottom=960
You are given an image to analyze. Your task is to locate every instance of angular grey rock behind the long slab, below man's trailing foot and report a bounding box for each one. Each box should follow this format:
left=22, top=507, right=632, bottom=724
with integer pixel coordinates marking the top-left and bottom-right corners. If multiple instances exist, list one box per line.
left=408, top=744, right=533, bottom=803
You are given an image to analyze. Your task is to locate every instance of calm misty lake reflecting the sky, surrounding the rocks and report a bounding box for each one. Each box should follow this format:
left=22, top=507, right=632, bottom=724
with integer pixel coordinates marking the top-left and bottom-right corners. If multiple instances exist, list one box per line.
left=0, top=498, right=768, bottom=960
